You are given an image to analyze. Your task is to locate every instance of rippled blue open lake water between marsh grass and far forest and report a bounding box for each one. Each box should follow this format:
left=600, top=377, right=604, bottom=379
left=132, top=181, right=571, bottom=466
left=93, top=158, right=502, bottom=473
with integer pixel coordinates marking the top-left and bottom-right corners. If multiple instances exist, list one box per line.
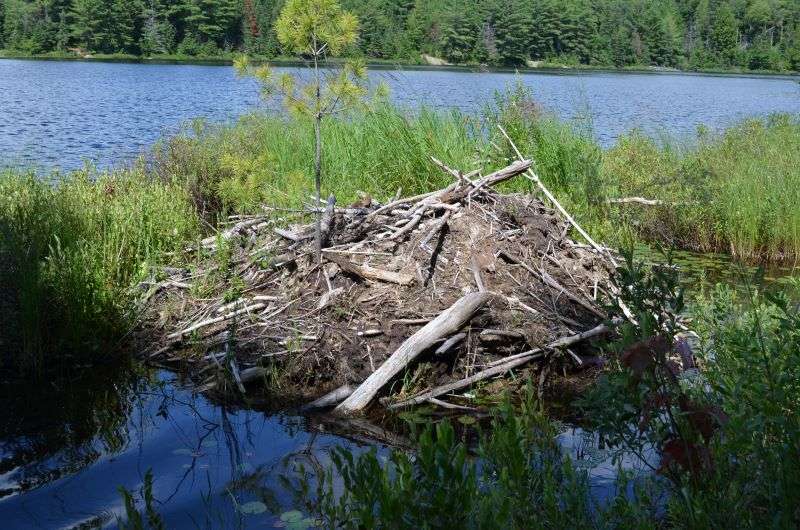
left=0, top=60, right=800, bottom=169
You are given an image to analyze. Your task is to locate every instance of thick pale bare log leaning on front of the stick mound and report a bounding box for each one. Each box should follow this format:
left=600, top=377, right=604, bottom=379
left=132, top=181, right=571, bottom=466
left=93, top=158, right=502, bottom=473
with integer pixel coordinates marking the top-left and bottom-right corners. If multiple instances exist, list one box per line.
left=336, top=293, right=493, bottom=415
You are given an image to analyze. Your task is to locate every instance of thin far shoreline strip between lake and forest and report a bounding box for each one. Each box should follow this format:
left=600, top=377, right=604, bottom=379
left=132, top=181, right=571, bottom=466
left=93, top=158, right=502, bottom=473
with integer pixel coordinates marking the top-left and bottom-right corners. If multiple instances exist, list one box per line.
left=0, top=50, right=800, bottom=80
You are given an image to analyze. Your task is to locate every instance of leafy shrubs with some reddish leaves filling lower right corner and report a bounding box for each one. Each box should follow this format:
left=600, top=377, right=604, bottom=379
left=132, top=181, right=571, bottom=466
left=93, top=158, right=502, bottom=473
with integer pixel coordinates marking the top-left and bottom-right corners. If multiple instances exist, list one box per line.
left=583, top=256, right=800, bottom=528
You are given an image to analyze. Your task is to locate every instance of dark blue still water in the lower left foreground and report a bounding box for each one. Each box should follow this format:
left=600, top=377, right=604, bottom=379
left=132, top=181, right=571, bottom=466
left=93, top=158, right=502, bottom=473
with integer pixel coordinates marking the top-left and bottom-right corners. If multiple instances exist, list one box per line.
left=0, top=369, right=382, bottom=529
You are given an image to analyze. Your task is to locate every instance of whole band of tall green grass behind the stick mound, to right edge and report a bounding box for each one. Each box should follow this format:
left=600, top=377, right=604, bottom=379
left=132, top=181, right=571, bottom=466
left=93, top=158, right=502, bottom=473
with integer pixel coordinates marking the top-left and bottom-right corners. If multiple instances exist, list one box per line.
left=152, top=89, right=800, bottom=262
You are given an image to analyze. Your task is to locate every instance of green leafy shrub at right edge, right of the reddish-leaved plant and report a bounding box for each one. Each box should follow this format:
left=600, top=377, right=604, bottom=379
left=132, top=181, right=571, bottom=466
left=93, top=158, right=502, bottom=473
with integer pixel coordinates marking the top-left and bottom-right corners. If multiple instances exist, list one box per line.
left=693, top=287, right=800, bottom=528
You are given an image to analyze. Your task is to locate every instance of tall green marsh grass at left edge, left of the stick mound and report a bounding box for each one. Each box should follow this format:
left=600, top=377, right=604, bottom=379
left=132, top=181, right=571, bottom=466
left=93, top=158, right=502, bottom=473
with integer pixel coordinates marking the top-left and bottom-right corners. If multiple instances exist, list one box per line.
left=0, top=170, right=198, bottom=367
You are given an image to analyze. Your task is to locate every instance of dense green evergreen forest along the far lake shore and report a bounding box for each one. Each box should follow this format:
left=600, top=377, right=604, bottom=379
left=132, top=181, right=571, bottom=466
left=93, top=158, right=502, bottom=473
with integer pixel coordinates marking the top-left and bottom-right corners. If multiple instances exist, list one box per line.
left=0, top=0, right=800, bottom=70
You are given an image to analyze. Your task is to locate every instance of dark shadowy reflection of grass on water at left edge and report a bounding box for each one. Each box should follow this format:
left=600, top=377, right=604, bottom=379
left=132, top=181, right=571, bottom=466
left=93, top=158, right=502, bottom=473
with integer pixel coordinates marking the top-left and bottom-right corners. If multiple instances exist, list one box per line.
left=0, top=354, right=143, bottom=499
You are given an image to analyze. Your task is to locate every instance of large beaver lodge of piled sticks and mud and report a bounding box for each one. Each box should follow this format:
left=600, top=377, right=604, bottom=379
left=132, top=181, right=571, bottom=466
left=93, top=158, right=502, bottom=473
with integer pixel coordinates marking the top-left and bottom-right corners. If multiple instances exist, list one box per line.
left=139, top=151, right=636, bottom=414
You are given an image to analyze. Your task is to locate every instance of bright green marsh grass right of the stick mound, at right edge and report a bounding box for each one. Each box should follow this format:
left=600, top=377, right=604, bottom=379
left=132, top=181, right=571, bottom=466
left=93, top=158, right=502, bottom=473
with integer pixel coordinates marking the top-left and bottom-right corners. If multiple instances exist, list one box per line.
left=604, top=116, right=800, bottom=262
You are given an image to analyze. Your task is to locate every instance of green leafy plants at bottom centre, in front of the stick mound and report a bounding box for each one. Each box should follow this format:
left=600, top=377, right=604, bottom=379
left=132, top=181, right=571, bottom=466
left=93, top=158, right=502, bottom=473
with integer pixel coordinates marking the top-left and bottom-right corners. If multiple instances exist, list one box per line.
left=312, top=394, right=651, bottom=529
